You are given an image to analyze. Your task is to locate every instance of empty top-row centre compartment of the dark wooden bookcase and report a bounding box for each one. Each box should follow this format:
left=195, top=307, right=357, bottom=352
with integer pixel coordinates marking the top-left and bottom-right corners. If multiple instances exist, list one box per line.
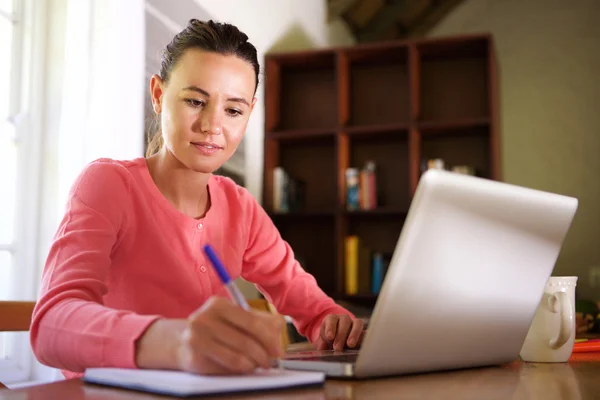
left=345, top=45, right=409, bottom=126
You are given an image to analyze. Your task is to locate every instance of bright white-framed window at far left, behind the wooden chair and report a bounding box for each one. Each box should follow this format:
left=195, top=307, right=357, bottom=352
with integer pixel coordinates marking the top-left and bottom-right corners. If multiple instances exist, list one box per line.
left=0, top=0, right=43, bottom=385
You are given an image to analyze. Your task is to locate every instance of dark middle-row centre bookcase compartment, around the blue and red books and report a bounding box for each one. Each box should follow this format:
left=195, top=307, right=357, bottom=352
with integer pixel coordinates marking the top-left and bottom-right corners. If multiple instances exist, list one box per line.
left=348, top=132, right=410, bottom=212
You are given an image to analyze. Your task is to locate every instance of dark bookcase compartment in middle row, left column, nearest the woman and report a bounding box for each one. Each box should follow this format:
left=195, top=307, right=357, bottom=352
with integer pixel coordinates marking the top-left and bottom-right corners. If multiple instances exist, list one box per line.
left=277, top=135, right=337, bottom=213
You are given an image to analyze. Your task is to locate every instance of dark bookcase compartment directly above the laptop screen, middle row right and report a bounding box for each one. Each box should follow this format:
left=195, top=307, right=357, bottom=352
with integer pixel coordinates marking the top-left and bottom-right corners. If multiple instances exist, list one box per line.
left=421, top=127, right=492, bottom=178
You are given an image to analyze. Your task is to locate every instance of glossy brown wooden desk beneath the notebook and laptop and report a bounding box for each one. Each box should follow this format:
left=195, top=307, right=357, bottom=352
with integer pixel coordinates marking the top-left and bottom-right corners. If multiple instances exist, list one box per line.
left=0, top=355, right=600, bottom=400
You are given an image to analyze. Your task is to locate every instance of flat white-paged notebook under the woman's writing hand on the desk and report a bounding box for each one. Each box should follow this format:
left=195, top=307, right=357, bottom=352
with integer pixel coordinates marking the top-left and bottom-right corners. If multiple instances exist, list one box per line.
left=82, top=368, right=325, bottom=397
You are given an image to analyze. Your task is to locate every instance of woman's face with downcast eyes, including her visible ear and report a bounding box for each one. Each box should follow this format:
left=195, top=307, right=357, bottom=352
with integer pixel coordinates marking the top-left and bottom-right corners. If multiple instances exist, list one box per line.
left=151, top=49, right=256, bottom=173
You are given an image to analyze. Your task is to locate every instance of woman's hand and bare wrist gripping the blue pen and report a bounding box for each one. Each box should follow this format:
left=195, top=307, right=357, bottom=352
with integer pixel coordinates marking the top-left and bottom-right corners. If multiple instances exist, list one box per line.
left=136, top=297, right=285, bottom=375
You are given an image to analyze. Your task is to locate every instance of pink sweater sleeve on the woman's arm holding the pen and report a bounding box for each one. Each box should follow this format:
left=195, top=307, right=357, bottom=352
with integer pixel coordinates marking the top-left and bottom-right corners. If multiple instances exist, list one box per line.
left=30, top=161, right=157, bottom=372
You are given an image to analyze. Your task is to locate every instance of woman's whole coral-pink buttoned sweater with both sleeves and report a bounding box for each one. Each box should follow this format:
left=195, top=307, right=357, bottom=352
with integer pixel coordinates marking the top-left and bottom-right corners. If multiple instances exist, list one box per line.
left=31, top=158, right=349, bottom=378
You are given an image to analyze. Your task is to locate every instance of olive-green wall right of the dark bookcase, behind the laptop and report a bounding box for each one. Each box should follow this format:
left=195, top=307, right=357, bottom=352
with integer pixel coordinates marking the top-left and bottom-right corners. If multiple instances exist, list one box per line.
left=430, top=0, right=600, bottom=299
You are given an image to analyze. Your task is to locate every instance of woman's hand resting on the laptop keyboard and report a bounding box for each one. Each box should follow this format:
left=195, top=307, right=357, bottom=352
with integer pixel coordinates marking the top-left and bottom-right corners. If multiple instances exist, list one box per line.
left=316, top=314, right=364, bottom=351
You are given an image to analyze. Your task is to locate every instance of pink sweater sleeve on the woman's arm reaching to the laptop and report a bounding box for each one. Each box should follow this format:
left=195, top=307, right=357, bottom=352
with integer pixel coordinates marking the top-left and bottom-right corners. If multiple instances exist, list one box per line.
left=242, top=194, right=354, bottom=343
